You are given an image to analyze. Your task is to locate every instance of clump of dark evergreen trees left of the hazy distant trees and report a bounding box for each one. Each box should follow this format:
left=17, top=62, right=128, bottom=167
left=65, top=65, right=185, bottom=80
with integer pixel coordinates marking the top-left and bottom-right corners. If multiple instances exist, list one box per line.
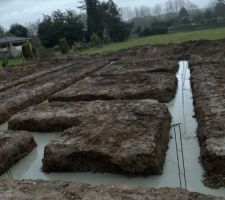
left=0, top=0, right=132, bottom=48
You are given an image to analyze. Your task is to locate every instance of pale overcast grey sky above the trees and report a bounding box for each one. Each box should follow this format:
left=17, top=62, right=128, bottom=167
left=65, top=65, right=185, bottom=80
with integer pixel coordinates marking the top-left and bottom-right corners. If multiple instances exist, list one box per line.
left=0, top=0, right=210, bottom=29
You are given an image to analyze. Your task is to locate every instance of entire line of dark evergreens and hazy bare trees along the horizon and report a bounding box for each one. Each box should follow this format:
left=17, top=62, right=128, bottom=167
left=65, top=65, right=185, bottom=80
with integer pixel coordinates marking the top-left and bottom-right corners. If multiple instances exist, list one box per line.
left=0, top=0, right=225, bottom=48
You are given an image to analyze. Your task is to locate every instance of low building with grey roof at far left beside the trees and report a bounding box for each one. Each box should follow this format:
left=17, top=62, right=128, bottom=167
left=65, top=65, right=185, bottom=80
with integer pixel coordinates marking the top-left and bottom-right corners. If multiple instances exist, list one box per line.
left=0, top=36, right=31, bottom=58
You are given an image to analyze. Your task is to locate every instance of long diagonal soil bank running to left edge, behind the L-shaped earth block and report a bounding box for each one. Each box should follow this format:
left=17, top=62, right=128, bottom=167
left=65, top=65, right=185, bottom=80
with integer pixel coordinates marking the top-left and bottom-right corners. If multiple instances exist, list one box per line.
left=0, top=59, right=108, bottom=123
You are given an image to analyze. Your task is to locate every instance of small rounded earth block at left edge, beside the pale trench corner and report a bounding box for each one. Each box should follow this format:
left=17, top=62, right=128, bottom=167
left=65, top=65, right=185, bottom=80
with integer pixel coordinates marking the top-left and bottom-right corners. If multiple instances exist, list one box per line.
left=0, top=131, right=36, bottom=174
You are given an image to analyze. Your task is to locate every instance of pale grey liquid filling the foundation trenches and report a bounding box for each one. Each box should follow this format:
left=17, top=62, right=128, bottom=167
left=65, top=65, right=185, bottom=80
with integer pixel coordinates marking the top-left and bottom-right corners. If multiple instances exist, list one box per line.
left=0, top=61, right=225, bottom=196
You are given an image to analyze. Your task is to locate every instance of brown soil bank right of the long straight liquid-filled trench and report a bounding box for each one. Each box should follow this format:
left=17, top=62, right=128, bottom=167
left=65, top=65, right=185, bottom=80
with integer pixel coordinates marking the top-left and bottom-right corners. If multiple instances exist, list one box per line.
left=191, top=60, right=225, bottom=188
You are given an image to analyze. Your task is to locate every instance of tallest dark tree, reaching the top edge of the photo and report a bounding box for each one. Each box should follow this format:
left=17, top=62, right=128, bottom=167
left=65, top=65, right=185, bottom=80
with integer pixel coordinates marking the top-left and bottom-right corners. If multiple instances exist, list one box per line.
left=80, top=0, right=132, bottom=41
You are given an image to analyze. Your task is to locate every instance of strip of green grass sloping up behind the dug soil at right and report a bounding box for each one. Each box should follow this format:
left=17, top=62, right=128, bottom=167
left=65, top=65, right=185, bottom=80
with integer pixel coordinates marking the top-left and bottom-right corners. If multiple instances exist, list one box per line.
left=83, top=28, right=225, bottom=54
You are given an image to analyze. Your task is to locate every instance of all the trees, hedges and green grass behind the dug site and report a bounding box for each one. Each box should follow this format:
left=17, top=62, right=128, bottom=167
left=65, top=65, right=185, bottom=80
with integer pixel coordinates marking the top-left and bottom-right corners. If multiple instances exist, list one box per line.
left=0, top=0, right=225, bottom=66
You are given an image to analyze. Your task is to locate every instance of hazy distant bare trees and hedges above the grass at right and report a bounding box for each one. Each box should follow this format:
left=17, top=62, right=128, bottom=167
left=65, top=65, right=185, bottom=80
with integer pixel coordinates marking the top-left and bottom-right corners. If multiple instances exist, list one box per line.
left=131, top=0, right=225, bottom=36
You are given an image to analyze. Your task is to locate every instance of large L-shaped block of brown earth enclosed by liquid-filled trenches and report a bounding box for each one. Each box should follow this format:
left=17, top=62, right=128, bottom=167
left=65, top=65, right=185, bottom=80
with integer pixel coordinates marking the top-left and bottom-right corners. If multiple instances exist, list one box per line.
left=9, top=100, right=171, bottom=174
